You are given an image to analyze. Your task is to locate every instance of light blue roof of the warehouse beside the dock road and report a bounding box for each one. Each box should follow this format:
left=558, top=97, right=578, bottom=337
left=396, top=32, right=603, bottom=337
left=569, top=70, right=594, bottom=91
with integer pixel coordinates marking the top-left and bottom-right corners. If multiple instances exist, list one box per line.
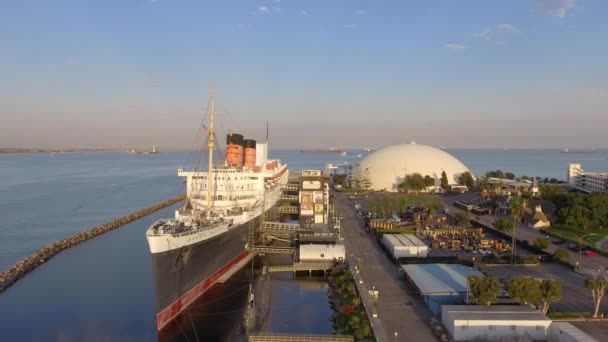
left=401, top=264, right=482, bottom=296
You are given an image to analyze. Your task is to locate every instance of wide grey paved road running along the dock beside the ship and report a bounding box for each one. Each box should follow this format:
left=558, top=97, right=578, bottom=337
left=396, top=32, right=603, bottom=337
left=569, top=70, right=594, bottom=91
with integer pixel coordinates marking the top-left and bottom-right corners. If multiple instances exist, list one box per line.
left=334, top=193, right=437, bottom=341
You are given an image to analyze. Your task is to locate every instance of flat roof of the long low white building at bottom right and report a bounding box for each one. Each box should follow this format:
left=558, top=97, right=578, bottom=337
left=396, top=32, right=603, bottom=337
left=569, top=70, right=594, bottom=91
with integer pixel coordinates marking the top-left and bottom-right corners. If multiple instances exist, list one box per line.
left=441, top=305, right=551, bottom=321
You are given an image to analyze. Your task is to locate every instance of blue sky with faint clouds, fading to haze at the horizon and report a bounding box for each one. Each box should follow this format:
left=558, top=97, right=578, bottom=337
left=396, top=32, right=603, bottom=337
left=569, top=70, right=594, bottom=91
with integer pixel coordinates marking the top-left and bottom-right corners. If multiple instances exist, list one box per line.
left=0, top=0, right=608, bottom=149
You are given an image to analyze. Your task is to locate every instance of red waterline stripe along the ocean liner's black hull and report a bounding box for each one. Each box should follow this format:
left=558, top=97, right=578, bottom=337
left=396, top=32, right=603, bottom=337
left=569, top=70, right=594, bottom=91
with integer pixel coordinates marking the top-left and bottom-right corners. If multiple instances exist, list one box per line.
left=156, top=252, right=249, bottom=330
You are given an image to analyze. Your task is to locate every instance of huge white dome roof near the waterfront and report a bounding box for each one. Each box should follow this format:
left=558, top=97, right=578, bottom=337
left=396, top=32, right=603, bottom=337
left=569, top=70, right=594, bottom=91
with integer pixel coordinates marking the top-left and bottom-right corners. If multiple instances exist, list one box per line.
left=359, top=143, right=469, bottom=191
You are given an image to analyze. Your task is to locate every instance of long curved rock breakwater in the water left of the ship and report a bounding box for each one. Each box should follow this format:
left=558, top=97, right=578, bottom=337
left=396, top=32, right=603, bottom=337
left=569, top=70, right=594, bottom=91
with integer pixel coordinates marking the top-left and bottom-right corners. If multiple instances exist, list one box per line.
left=0, top=195, right=186, bottom=293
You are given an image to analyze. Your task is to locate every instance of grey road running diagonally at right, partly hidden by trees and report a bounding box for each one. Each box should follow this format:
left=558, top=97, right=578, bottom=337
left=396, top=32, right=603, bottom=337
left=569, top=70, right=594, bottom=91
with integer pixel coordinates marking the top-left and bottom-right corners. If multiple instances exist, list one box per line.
left=441, top=196, right=608, bottom=276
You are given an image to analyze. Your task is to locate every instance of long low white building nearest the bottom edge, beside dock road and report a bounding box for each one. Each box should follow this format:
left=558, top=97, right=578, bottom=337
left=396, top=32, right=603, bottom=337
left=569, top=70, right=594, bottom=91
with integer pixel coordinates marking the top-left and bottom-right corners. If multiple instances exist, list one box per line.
left=441, top=305, right=551, bottom=341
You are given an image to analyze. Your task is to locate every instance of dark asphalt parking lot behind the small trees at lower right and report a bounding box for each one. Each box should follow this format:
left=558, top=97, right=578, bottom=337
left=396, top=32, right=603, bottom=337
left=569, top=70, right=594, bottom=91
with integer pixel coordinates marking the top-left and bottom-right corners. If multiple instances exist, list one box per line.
left=481, top=263, right=608, bottom=312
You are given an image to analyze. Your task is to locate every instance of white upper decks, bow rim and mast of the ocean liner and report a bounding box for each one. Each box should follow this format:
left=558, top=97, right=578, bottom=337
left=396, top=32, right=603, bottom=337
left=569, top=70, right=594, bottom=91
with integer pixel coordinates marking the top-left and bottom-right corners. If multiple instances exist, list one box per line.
left=146, top=93, right=289, bottom=254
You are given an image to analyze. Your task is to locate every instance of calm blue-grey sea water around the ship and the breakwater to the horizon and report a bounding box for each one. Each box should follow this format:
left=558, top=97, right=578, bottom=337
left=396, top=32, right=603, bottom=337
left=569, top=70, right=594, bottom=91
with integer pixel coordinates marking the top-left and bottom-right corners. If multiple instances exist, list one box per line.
left=0, top=150, right=608, bottom=341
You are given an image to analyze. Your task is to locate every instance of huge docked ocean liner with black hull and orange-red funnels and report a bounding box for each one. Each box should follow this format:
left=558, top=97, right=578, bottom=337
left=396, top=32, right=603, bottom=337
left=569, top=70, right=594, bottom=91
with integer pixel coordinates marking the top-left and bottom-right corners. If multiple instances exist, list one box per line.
left=146, top=92, right=289, bottom=331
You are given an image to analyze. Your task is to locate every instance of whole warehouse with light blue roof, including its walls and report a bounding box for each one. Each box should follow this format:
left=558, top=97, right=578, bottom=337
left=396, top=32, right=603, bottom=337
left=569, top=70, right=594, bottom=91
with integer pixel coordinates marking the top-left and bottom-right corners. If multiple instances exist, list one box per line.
left=401, top=264, right=482, bottom=316
